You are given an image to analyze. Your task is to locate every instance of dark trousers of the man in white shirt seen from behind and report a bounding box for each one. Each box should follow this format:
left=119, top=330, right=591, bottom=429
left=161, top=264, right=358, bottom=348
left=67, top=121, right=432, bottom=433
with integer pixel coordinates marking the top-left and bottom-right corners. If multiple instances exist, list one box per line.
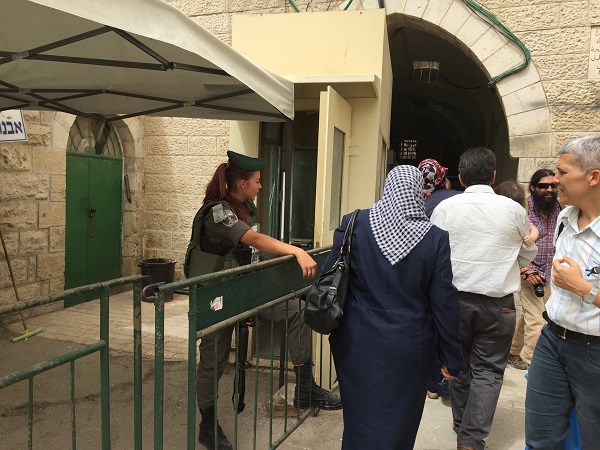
left=450, top=292, right=516, bottom=450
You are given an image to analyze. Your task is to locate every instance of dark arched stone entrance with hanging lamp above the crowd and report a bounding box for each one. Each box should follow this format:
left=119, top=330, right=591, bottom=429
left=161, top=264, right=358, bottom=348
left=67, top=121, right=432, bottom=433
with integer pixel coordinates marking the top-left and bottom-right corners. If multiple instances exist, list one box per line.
left=386, top=0, right=551, bottom=181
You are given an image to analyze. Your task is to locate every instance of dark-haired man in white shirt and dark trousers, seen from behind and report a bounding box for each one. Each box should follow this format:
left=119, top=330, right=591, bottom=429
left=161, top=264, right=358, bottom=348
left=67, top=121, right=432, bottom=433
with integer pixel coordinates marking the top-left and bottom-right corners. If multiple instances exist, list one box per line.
left=431, top=147, right=537, bottom=450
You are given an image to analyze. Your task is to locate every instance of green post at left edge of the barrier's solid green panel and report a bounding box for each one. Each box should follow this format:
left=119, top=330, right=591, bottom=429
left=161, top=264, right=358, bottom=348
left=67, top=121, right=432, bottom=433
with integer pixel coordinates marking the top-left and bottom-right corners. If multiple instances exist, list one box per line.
left=187, top=285, right=198, bottom=450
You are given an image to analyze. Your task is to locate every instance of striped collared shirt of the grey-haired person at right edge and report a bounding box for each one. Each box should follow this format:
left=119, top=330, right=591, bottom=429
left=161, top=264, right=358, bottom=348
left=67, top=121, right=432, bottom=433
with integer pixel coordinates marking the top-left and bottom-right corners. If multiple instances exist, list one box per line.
left=546, top=206, right=600, bottom=336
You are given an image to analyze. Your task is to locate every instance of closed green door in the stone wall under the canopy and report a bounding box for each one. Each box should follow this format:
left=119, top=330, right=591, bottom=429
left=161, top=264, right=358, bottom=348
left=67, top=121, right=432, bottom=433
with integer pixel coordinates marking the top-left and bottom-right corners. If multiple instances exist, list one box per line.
left=65, top=152, right=122, bottom=306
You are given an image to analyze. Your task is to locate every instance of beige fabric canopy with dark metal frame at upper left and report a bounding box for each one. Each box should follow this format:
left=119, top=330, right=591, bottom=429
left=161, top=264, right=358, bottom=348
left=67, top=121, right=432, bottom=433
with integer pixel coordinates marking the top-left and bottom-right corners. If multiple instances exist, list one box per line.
left=0, top=0, right=293, bottom=122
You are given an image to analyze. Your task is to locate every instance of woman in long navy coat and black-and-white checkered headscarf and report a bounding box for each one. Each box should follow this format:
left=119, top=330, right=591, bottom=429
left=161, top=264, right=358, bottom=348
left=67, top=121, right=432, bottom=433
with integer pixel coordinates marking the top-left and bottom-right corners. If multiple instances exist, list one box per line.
left=324, top=166, right=462, bottom=450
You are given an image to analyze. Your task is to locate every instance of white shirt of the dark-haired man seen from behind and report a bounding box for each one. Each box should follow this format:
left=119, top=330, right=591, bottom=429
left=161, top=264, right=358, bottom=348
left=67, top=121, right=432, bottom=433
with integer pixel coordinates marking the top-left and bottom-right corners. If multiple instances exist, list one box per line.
left=431, top=185, right=537, bottom=298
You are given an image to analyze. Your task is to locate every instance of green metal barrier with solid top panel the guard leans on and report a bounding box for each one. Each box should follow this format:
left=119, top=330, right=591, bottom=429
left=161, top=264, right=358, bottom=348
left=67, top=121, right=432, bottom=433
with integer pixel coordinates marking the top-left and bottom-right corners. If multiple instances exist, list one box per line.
left=149, top=247, right=335, bottom=449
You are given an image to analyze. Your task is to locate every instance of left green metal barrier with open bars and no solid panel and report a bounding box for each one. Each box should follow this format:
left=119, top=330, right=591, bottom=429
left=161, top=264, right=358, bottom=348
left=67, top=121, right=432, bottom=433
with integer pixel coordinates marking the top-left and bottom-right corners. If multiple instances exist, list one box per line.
left=0, top=275, right=142, bottom=450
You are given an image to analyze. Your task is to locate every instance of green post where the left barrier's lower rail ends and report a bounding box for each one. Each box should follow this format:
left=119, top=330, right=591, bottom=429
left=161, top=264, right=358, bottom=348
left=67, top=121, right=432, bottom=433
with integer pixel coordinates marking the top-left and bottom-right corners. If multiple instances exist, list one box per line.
left=100, top=288, right=110, bottom=450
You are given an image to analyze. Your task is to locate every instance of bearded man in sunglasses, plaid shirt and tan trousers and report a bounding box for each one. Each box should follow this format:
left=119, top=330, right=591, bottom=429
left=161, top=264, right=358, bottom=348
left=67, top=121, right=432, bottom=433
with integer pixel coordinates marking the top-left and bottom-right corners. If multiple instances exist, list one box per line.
left=508, top=169, right=561, bottom=370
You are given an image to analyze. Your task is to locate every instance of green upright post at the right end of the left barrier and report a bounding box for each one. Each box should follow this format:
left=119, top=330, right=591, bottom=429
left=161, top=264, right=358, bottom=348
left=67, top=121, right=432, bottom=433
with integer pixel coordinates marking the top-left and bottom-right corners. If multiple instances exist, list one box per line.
left=133, top=281, right=142, bottom=450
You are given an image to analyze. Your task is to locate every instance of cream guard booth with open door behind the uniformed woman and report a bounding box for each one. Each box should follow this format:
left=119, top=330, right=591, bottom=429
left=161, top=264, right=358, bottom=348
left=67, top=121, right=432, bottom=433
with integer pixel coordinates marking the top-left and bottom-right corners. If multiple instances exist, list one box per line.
left=230, top=9, right=392, bottom=386
